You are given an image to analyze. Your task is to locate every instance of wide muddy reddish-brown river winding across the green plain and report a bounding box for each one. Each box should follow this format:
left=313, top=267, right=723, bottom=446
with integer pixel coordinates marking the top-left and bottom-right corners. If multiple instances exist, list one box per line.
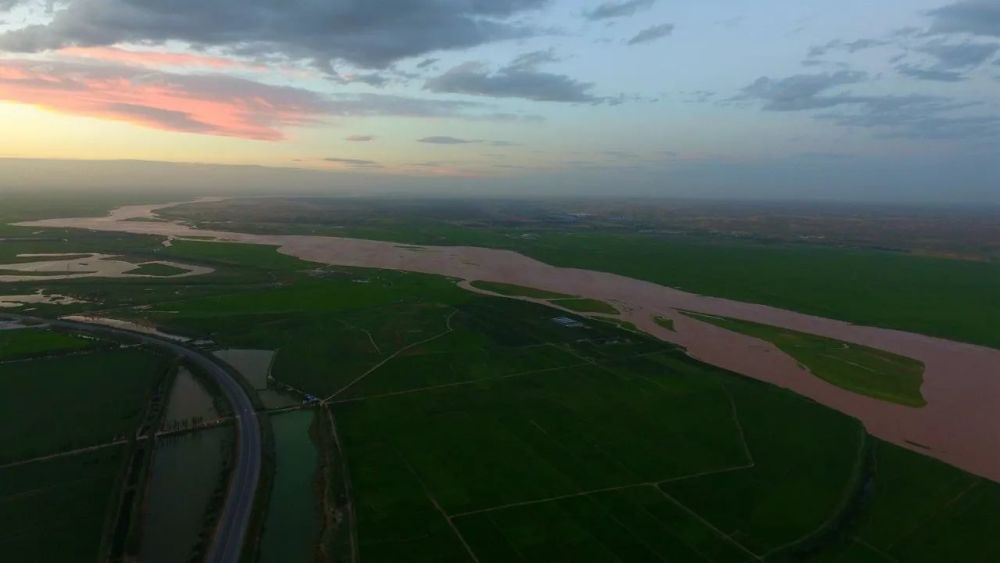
left=17, top=205, right=1000, bottom=482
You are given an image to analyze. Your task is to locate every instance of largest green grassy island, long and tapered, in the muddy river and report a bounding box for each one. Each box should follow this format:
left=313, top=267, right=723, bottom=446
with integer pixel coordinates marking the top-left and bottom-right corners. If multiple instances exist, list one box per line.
left=686, top=313, right=927, bottom=407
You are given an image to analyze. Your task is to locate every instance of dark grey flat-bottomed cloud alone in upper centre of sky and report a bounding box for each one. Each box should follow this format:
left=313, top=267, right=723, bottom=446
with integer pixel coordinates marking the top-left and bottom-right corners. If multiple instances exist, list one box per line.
left=424, top=61, right=603, bottom=103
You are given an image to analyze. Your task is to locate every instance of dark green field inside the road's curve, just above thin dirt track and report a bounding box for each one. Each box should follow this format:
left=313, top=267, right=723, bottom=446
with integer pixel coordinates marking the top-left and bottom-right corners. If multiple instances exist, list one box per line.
left=0, top=349, right=168, bottom=463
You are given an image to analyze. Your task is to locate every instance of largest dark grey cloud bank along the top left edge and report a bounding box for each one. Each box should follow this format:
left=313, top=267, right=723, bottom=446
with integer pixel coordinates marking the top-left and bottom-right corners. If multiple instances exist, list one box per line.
left=0, top=0, right=548, bottom=69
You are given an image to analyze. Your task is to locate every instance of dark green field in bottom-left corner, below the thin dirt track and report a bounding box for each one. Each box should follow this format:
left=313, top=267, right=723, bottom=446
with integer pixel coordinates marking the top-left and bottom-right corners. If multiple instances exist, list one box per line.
left=0, top=446, right=125, bottom=563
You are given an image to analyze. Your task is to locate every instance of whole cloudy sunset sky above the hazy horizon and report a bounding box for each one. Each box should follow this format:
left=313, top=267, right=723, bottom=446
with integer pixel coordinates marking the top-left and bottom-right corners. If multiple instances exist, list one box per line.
left=0, top=0, right=1000, bottom=204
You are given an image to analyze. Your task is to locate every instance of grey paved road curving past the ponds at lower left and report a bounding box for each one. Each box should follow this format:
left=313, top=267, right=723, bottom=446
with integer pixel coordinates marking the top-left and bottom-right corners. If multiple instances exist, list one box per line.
left=0, top=312, right=261, bottom=563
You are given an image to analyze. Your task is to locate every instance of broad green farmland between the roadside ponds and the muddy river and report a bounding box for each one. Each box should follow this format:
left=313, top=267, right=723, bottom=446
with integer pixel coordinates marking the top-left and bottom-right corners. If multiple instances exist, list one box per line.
left=97, top=268, right=1000, bottom=563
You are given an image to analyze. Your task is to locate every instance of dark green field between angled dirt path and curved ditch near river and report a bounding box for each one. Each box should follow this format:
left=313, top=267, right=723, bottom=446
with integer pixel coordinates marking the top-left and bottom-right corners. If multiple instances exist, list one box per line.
left=661, top=378, right=867, bottom=556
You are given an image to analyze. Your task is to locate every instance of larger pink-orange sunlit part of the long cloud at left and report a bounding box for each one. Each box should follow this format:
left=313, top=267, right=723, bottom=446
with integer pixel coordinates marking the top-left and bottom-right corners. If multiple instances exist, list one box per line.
left=0, top=59, right=331, bottom=141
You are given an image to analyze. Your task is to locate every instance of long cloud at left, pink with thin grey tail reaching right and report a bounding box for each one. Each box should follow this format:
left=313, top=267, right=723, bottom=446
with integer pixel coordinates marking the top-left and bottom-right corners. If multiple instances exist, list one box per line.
left=0, top=58, right=509, bottom=140
